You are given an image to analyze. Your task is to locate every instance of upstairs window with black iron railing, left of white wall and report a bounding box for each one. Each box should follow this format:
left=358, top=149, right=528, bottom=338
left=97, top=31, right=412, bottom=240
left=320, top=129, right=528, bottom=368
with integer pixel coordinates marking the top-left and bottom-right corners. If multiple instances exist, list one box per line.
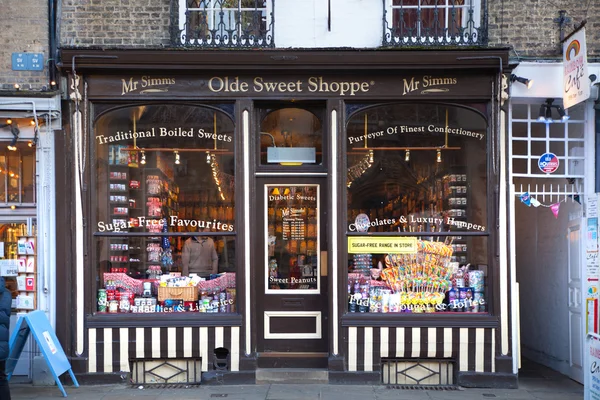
left=171, top=0, right=274, bottom=48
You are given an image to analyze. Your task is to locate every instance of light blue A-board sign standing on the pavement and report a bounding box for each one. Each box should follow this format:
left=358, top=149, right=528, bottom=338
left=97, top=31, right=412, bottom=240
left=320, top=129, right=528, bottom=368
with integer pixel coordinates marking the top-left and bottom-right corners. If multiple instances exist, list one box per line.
left=6, top=310, right=79, bottom=397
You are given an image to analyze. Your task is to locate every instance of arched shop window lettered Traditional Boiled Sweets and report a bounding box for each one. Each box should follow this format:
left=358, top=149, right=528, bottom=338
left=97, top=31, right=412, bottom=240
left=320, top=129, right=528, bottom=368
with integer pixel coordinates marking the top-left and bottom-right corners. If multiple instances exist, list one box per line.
left=92, top=105, right=237, bottom=313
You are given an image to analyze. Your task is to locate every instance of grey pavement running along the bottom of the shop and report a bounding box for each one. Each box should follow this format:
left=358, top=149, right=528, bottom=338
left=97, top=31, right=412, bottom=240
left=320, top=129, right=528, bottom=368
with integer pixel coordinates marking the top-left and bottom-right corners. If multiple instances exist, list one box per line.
left=10, top=363, right=583, bottom=400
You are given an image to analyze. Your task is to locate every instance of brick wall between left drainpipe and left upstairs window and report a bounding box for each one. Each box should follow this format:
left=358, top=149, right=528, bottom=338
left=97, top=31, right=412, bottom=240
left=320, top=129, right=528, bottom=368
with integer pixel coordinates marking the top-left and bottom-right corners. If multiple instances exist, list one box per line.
left=60, top=0, right=171, bottom=48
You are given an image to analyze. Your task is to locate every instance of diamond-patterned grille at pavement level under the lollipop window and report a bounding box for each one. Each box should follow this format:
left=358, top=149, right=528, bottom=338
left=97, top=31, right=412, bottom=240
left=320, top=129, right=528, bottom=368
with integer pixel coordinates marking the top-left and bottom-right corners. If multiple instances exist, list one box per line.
left=381, top=358, right=455, bottom=390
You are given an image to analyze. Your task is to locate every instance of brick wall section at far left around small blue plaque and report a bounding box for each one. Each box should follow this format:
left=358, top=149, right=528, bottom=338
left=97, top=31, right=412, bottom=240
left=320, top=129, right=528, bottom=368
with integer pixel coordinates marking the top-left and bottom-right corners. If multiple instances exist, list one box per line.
left=0, top=0, right=49, bottom=90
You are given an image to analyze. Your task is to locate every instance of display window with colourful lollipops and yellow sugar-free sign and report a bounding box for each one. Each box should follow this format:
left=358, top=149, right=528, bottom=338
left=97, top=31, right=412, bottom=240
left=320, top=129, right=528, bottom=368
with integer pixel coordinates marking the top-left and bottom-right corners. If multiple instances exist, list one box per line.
left=346, top=103, right=490, bottom=314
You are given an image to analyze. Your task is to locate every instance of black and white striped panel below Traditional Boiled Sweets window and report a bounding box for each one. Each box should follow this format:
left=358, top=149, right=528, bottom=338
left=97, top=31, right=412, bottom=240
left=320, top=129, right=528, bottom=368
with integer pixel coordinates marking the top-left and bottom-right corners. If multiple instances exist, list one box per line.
left=88, top=327, right=240, bottom=373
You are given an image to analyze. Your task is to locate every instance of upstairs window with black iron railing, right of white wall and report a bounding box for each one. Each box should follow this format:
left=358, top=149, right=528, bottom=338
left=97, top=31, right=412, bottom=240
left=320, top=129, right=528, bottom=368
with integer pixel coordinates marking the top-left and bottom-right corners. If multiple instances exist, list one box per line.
left=382, top=0, right=488, bottom=47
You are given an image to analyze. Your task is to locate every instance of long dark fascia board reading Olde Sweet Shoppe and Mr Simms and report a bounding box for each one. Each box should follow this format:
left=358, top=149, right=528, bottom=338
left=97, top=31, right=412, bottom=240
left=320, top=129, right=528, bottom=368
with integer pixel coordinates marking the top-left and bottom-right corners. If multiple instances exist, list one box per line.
left=88, top=71, right=492, bottom=99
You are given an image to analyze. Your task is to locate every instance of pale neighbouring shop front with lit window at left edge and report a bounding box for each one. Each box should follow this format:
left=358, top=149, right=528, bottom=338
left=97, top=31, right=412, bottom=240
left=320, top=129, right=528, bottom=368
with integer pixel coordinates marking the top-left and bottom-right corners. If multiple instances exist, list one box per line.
left=0, top=94, right=60, bottom=382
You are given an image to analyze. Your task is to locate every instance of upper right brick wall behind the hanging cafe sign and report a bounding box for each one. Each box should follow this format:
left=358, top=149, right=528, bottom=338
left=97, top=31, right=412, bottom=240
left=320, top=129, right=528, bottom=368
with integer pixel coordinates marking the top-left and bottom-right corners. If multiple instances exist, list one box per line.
left=488, top=0, right=600, bottom=58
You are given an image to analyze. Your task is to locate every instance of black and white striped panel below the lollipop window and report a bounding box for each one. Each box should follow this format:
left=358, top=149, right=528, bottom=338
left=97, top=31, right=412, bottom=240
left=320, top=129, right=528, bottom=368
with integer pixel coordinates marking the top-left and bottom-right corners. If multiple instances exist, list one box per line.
left=344, top=327, right=496, bottom=372
